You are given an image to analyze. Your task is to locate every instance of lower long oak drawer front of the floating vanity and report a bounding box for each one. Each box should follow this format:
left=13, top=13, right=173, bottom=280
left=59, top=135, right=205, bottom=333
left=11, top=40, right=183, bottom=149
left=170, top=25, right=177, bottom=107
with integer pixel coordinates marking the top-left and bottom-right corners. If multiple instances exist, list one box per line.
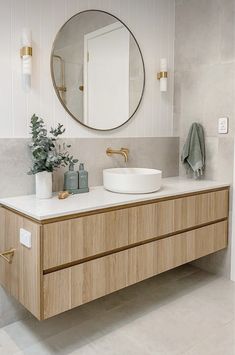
left=44, top=221, right=227, bottom=318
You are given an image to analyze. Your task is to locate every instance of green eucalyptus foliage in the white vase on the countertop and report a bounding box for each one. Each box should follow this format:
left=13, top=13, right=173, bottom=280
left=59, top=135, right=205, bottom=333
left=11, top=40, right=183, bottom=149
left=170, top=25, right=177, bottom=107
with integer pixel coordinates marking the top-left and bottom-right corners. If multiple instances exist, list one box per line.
left=28, top=114, right=78, bottom=175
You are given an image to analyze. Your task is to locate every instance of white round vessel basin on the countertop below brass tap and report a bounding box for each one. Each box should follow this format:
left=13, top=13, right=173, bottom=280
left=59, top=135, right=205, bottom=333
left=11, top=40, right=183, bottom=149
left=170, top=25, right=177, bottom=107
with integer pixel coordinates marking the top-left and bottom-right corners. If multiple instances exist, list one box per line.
left=103, top=168, right=162, bottom=194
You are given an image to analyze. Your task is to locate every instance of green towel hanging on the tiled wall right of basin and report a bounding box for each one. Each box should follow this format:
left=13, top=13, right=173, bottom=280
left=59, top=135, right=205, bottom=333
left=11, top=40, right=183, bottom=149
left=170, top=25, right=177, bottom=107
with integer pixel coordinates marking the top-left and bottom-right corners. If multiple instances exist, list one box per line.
left=181, top=122, right=205, bottom=179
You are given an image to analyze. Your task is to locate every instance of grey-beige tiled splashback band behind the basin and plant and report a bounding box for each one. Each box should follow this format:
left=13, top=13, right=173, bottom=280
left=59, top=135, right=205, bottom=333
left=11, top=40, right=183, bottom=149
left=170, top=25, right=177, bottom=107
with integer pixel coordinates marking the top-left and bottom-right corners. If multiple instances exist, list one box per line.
left=0, top=137, right=179, bottom=197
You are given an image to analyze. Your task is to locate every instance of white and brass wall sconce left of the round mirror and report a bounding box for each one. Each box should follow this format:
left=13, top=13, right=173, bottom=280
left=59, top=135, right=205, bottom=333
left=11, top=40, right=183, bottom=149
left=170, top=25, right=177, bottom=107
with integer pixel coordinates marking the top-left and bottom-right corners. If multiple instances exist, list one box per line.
left=20, top=28, right=33, bottom=91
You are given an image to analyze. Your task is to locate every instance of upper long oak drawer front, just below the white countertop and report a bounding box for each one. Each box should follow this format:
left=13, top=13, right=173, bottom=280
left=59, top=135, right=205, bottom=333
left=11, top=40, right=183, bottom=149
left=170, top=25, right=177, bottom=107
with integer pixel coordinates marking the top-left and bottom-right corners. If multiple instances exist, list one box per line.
left=43, top=189, right=228, bottom=270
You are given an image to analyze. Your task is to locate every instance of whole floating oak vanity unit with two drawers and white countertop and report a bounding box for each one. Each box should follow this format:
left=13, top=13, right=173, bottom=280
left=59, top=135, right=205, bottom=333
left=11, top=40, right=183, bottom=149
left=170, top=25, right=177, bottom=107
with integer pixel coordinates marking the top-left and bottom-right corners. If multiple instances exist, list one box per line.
left=0, top=178, right=229, bottom=320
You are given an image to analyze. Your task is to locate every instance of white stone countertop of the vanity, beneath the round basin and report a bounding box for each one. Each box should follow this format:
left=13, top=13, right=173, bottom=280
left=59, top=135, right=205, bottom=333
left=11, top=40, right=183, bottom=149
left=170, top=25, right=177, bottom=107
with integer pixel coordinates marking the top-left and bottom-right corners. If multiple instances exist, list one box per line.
left=0, top=176, right=229, bottom=221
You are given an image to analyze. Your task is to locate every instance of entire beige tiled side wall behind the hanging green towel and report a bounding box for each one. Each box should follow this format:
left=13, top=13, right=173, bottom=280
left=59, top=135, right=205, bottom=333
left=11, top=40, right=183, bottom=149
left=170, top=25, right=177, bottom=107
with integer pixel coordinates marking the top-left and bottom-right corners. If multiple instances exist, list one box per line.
left=174, top=0, right=235, bottom=277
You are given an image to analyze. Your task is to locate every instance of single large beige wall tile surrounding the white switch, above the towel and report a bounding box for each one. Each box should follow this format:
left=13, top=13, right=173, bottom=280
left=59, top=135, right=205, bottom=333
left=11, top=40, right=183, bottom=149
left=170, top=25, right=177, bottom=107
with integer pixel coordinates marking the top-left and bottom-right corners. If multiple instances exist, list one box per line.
left=174, top=62, right=235, bottom=138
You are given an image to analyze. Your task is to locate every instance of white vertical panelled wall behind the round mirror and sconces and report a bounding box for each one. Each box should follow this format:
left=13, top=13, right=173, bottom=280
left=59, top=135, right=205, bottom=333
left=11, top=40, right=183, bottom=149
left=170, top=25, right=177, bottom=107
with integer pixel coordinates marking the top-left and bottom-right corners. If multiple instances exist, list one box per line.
left=0, top=0, right=174, bottom=138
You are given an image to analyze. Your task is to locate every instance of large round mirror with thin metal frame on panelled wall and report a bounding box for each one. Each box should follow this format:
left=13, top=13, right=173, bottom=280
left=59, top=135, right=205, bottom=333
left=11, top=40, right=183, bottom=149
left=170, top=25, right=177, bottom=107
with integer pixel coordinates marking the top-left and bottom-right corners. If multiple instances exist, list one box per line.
left=51, top=10, right=145, bottom=130
